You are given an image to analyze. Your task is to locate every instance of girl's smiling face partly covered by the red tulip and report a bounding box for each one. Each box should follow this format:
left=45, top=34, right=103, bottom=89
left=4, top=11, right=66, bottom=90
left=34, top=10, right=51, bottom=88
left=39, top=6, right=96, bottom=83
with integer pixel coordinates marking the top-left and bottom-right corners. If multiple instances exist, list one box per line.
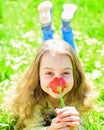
left=39, top=52, right=74, bottom=98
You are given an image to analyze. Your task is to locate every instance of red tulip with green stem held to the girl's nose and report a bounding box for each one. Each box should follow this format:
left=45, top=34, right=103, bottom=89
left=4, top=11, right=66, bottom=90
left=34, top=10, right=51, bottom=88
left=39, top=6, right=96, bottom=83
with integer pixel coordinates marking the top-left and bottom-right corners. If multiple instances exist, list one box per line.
left=50, top=77, right=66, bottom=107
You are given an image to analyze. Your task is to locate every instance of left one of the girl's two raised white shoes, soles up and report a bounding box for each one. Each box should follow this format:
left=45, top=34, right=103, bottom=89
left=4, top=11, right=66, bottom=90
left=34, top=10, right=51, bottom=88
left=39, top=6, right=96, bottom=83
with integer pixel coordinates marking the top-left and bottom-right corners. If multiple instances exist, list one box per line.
left=38, top=1, right=52, bottom=26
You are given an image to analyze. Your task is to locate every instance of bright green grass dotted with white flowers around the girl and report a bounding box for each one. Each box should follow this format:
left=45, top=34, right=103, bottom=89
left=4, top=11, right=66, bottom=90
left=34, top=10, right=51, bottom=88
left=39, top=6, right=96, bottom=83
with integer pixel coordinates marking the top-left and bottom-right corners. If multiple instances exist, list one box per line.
left=0, top=0, right=104, bottom=130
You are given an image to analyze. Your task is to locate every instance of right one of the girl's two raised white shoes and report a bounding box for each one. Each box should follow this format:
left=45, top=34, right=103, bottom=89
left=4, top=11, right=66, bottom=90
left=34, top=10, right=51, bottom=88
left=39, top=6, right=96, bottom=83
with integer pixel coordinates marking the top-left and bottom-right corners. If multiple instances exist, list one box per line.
left=62, top=4, right=77, bottom=22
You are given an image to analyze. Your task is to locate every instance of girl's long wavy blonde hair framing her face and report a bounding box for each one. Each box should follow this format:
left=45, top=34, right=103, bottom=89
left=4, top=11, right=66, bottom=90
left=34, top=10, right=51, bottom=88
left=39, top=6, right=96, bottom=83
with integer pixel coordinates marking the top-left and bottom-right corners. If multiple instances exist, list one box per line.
left=6, top=39, right=92, bottom=127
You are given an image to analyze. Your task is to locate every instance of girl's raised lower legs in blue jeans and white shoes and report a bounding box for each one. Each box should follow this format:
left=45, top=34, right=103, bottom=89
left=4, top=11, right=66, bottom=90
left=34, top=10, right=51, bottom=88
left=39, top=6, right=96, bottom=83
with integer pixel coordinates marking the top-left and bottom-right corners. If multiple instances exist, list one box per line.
left=38, top=1, right=77, bottom=52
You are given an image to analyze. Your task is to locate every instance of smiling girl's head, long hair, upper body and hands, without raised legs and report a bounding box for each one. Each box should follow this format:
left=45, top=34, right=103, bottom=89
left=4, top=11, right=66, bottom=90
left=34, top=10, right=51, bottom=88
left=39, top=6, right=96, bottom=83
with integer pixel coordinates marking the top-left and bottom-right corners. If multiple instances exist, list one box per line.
left=6, top=39, right=92, bottom=130
